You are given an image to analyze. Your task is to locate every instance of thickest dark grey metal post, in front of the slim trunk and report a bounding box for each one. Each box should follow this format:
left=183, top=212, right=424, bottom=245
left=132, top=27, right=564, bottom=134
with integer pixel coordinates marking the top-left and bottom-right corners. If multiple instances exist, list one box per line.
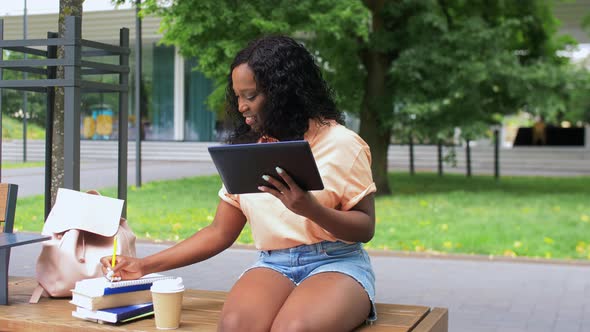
left=64, top=16, right=82, bottom=190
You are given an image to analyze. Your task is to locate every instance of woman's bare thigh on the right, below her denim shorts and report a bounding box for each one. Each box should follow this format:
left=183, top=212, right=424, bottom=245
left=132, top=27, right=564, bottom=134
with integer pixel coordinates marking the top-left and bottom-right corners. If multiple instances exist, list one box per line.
left=271, top=272, right=371, bottom=332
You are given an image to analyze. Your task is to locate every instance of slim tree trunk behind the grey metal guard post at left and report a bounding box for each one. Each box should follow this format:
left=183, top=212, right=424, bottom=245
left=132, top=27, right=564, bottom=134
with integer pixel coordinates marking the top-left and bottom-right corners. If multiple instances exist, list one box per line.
left=51, top=0, right=84, bottom=206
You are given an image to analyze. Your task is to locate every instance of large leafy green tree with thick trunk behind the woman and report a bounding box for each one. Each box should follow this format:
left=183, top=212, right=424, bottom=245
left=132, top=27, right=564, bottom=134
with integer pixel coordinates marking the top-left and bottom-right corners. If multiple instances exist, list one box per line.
left=138, top=0, right=562, bottom=194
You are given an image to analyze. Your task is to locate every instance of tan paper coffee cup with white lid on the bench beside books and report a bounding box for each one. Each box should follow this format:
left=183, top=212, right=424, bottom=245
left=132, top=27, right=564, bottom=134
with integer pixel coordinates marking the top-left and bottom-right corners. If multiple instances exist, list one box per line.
left=150, top=277, right=184, bottom=330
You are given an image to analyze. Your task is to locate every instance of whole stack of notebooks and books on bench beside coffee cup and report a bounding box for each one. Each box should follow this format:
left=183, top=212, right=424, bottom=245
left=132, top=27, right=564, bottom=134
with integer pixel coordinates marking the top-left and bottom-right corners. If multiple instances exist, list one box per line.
left=70, top=274, right=173, bottom=324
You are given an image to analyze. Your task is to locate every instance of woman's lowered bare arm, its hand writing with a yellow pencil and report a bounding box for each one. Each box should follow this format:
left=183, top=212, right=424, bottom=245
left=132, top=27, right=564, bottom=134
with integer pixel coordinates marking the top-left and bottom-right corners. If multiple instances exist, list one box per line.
left=101, top=200, right=246, bottom=279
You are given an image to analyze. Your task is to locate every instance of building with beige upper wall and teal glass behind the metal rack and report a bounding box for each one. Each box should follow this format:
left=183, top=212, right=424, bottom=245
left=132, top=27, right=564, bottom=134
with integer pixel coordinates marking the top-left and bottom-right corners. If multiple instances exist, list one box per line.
left=2, top=10, right=218, bottom=142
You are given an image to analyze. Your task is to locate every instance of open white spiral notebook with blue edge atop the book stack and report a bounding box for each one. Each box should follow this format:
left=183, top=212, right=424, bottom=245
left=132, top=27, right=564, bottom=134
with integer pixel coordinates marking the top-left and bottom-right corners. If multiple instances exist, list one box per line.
left=72, top=273, right=174, bottom=297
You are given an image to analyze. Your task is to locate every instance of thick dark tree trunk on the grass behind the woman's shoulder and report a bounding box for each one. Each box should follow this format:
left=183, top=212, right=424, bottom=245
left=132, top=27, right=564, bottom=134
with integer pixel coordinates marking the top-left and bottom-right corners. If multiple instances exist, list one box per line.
left=359, top=0, right=392, bottom=195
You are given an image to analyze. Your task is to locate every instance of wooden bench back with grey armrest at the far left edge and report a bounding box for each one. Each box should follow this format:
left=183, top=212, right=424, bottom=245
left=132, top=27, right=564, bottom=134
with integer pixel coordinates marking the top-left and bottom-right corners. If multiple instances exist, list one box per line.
left=0, top=183, right=51, bottom=305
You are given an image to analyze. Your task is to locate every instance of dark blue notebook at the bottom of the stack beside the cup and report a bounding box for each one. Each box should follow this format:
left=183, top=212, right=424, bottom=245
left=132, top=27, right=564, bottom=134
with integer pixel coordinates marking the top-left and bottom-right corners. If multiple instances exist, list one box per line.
left=72, top=302, right=154, bottom=323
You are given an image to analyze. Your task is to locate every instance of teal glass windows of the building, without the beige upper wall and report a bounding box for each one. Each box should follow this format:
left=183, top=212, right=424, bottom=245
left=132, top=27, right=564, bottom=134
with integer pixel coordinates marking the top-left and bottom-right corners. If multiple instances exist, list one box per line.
left=81, top=42, right=217, bottom=142
